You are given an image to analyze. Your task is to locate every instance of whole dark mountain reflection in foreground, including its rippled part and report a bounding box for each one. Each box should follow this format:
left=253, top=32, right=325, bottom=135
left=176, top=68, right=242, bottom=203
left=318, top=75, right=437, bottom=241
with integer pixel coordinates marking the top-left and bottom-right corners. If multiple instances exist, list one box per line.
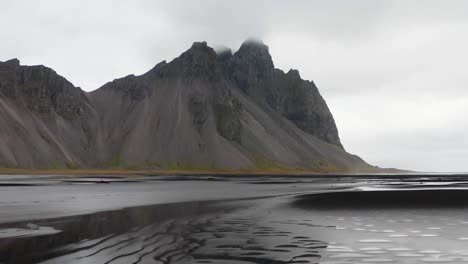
left=0, top=199, right=327, bottom=263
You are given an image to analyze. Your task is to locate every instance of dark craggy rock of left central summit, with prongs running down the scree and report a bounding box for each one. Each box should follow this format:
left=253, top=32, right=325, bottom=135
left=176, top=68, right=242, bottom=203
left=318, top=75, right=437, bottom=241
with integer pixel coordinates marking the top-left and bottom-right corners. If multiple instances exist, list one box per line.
left=155, top=42, right=247, bottom=142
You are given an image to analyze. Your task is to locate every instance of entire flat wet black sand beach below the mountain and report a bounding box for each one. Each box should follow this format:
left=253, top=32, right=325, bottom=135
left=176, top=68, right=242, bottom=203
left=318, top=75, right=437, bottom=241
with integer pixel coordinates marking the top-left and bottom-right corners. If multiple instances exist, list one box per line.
left=0, top=175, right=468, bottom=264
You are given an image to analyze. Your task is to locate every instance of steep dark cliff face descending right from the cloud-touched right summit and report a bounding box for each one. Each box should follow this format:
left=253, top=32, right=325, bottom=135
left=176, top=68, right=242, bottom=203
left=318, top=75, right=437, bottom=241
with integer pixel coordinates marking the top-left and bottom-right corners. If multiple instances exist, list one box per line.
left=226, top=41, right=343, bottom=148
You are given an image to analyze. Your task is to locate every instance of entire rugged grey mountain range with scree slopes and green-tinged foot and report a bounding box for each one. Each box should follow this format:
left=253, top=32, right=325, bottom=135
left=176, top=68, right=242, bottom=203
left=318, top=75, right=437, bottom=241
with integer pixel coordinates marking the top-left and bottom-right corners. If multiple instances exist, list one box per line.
left=0, top=41, right=371, bottom=171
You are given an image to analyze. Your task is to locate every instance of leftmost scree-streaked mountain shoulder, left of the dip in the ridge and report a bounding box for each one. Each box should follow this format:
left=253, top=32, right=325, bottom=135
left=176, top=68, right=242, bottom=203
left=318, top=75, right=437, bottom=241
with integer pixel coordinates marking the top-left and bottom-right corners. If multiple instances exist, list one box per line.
left=0, top=60, right=97, bottom=168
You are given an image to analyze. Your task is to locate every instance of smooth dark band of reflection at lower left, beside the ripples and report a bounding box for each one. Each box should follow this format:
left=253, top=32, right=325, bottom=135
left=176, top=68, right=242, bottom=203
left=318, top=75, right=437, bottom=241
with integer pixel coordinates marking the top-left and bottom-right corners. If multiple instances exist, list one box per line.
left=0, top=202, right=232, bottom=263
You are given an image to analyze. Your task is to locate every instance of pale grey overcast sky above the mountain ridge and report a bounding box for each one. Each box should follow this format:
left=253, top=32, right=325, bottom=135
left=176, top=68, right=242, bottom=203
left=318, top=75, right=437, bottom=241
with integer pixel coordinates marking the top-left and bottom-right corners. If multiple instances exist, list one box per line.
left=0, top=0, right=468, bottom=171
